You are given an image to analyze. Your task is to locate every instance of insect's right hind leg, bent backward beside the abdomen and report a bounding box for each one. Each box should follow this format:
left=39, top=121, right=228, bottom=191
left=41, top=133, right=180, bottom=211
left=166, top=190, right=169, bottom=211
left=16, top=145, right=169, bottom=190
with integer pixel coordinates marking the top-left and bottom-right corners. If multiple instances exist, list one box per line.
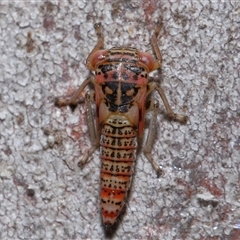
left=143, top=101, right=162, bottom=177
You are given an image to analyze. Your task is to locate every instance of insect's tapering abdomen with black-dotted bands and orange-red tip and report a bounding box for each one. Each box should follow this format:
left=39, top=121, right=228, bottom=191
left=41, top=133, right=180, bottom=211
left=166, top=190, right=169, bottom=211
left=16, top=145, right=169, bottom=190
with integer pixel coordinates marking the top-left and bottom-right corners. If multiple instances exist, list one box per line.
left=100, top=114, right=137, bottom=227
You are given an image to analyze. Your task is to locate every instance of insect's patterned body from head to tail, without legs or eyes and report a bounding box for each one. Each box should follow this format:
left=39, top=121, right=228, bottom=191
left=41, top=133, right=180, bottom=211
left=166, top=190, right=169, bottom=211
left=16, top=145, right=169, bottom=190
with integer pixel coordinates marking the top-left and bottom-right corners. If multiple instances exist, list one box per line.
left=95, top=48, right=148, bottom=227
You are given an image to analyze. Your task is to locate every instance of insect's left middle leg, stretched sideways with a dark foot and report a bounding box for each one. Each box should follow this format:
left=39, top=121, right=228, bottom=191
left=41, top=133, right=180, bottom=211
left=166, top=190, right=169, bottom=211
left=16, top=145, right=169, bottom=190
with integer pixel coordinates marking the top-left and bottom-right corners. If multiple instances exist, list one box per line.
left=55, top=76, right=94, bottom=107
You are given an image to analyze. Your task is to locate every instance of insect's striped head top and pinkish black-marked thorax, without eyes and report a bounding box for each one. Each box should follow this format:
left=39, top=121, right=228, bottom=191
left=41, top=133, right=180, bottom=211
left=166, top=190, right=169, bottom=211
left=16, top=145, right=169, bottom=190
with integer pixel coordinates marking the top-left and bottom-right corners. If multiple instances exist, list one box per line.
left=95, top=48, right=148, bottom=112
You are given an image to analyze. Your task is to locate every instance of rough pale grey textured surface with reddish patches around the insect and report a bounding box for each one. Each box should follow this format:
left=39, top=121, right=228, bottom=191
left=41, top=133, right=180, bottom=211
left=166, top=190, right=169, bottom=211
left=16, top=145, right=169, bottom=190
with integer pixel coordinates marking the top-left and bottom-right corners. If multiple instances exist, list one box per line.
left=0, top=0, right=240, bottom=240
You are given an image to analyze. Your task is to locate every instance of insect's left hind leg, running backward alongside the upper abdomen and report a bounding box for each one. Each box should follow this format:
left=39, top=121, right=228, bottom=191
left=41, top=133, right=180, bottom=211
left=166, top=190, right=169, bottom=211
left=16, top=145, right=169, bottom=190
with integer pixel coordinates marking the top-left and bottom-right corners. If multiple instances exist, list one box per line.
left=78, top=91, right=99, bottom=167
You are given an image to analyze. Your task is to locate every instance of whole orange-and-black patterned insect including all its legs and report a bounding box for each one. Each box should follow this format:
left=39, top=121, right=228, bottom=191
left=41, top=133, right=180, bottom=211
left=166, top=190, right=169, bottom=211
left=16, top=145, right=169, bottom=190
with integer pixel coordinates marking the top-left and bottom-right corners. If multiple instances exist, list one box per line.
left=55, top=22, right=187, bottom=231
